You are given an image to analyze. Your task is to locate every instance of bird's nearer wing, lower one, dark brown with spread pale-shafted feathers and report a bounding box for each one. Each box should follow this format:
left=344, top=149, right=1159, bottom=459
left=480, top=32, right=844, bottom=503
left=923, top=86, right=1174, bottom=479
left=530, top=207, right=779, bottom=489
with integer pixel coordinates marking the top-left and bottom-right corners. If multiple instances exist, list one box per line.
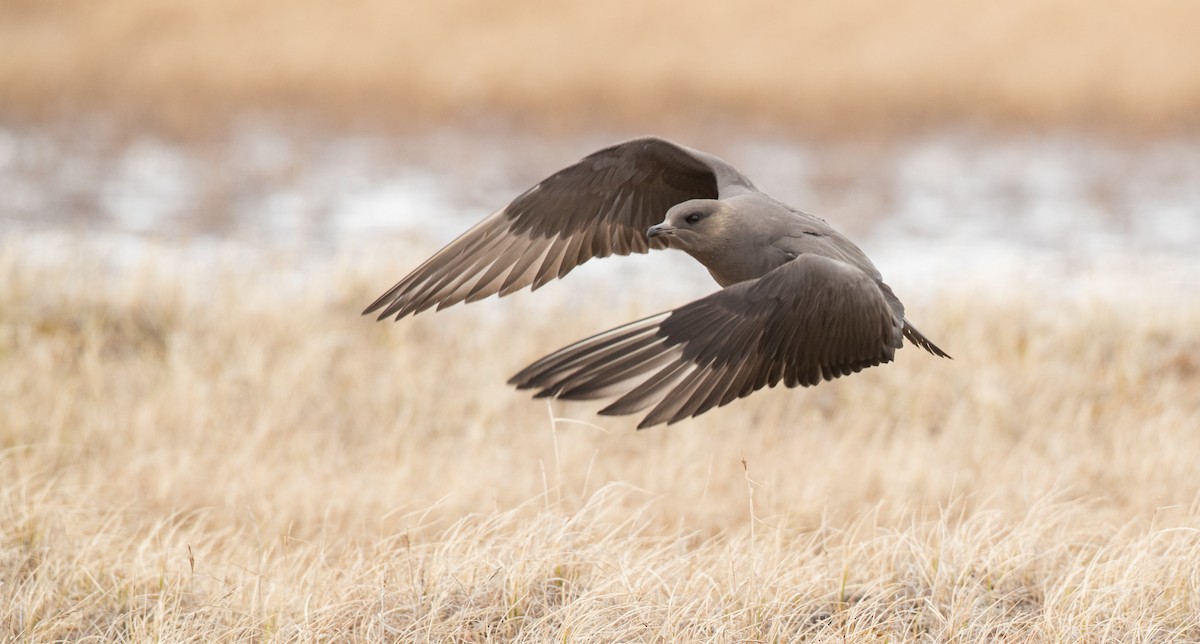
left=509, top=254, right=902, bottom=428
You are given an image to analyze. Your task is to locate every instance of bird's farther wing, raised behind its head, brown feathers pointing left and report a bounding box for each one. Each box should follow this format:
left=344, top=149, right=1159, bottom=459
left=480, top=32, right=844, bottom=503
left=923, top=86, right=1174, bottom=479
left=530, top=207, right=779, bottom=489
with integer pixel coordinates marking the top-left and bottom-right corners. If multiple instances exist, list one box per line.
left=362, top=137, right=752, bottom=319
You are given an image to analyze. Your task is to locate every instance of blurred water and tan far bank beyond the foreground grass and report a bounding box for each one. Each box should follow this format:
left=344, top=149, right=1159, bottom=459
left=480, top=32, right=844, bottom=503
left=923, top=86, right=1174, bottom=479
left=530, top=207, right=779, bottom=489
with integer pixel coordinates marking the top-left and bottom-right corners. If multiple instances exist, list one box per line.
left=0, top=0, right=1200, bottom=287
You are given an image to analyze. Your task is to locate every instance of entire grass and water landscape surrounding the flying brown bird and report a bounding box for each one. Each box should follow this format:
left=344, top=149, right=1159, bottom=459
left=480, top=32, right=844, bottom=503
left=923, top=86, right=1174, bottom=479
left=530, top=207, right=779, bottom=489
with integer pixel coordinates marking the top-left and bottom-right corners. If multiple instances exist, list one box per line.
left=0, top=0, right=1200, bottom=642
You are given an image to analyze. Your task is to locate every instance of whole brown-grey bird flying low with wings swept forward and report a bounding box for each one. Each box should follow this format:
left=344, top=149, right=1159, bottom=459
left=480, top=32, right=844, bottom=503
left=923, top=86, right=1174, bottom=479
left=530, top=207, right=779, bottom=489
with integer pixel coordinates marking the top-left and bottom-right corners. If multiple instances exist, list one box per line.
left=362, top=137, right=949, bottom=428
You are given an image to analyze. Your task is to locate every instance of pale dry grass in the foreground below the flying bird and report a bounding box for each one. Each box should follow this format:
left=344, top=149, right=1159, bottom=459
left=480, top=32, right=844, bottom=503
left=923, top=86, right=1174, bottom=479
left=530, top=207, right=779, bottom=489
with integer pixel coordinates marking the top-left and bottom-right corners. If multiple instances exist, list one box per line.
left=0, top=236, right=1200, bottom=642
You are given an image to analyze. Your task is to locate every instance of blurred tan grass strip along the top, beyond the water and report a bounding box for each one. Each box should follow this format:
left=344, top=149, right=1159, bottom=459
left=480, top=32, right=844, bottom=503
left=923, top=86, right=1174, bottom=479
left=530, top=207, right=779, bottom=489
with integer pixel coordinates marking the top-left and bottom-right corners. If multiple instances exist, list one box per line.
left=0, top=0, right=1200, bottom=132
